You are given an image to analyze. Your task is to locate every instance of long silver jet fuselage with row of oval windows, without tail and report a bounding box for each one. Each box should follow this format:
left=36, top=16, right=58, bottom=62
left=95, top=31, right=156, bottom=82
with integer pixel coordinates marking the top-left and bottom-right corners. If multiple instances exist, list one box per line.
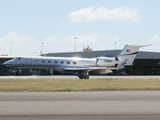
left=4, top=57, right=121, bottom=70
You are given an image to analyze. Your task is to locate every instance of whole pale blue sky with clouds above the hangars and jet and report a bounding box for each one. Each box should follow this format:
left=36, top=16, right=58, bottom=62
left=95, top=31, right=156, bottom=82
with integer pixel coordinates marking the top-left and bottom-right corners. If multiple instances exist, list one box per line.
left=0, top=0, right=160, bottom=56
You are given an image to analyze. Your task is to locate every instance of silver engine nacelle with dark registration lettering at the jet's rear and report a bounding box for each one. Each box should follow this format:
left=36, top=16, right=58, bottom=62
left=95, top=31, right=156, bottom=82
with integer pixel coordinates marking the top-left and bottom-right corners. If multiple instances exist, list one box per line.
left=97, top=57, right=122, bottom=67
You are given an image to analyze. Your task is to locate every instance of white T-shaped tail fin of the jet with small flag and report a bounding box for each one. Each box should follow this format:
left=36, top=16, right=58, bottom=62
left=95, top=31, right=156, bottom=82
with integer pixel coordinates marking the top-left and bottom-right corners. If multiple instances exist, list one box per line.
left=117, top=45, right=150, bottom=66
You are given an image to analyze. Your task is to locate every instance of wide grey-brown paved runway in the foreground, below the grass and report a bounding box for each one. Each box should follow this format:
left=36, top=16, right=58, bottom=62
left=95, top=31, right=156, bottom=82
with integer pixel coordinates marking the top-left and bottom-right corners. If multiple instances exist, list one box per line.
left=0, top=91, right=160, bottom=120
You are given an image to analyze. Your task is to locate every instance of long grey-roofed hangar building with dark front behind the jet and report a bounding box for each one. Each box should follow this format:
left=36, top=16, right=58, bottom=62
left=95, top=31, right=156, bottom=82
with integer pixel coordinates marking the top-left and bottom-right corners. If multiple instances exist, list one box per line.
left=0, top=48, right=160, bottom=75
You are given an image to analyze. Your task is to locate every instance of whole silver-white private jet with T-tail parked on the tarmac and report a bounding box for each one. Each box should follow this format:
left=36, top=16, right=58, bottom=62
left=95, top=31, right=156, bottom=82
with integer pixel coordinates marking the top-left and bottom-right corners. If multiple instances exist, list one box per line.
left=3, top=45, right=146, bottom=79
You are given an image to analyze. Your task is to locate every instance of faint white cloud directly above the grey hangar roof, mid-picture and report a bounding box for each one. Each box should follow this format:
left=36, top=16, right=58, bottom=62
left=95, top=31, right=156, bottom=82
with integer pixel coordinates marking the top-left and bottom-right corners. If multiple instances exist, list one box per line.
left=65, top=33, right=119, bottom=51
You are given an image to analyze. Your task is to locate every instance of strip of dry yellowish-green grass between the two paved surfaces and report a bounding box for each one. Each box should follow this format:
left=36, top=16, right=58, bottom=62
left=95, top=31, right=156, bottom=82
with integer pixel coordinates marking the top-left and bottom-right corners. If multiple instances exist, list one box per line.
left=0, top=78, right=160, bottom=92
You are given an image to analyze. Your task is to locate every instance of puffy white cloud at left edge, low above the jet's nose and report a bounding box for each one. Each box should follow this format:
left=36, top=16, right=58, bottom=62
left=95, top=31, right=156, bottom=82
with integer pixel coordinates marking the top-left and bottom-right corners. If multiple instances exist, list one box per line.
left=0, top=31, right=39, bottom=55
